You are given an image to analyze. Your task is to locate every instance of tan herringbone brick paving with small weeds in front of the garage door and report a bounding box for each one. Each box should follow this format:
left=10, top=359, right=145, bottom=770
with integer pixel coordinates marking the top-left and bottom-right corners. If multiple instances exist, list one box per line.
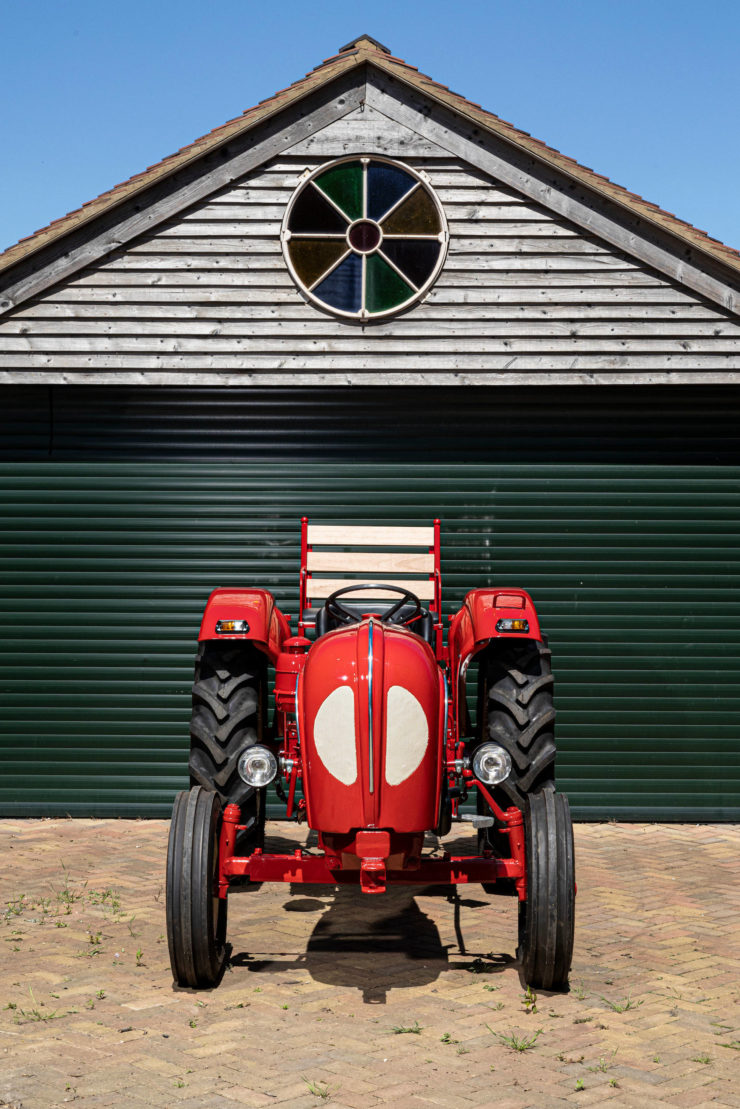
left=0, top=820, right=740, bottom=1109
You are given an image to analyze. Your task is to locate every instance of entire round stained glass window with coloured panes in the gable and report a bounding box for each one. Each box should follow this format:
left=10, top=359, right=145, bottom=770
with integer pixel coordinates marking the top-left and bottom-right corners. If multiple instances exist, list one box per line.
left=281, top=155, right=448, bottom=322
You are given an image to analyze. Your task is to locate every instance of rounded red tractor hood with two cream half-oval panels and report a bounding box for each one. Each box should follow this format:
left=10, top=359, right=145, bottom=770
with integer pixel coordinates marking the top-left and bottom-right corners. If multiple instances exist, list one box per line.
left=297, top=617, right=445, bottom=832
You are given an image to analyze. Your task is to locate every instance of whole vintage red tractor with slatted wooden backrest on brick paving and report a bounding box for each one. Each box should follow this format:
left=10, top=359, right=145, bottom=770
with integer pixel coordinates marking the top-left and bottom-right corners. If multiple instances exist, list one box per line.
left=166, top=518, right=575, bottom=989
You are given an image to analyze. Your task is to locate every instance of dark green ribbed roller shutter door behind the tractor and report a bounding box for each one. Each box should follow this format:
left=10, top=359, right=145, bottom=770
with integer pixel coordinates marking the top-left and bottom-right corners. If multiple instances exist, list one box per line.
left=0, top=387, right=740, bottom=821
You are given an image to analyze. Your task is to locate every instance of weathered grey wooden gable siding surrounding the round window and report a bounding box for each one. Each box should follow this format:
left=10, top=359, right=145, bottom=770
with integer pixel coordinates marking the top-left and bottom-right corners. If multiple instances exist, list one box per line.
left=0, top=106, right=740, bottom=384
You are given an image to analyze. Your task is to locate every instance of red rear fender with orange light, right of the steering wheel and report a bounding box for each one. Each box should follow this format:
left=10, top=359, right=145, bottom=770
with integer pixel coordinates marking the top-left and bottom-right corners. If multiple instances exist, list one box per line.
left=448, top=589, right=541, bottom=682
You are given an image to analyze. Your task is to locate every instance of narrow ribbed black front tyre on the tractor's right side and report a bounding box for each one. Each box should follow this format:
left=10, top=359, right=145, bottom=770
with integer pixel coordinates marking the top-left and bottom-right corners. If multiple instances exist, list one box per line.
left=517, top=790, right=576, bottom=990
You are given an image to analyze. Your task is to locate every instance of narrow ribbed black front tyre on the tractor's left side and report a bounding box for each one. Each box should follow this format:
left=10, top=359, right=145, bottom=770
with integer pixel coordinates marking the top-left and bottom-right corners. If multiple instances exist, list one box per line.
left=166, top=785, right=226, bottom=989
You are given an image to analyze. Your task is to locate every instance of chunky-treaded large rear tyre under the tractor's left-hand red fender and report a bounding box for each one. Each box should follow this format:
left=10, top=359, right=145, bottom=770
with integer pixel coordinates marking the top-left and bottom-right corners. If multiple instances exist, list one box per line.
left=189, top=640, right=267, bottom=851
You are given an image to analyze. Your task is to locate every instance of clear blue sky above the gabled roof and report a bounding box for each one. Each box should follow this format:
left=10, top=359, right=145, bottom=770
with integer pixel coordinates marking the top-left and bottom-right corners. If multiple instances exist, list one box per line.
left=0, top=0, right=740, bottom=250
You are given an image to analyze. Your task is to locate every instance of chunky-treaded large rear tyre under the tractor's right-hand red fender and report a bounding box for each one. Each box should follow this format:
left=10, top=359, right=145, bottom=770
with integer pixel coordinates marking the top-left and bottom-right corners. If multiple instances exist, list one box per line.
left=478, top=640, right=555, bottom=808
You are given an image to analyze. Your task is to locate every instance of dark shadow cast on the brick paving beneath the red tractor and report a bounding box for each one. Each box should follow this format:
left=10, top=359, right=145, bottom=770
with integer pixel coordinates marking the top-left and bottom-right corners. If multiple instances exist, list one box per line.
left=231, top=829, right=515, bottom=1005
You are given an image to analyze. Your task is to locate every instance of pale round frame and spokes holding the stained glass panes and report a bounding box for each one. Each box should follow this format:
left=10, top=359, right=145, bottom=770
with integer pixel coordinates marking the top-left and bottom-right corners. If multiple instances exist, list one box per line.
left=280, top=154, right=449, bottom=326
